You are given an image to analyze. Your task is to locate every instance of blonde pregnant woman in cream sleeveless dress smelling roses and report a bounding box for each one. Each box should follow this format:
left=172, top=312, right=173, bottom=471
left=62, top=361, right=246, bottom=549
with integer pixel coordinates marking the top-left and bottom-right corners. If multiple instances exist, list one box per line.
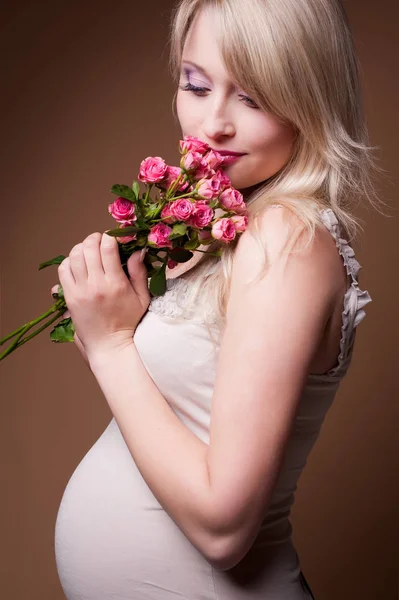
left=55, top=0, right=379, bottom=600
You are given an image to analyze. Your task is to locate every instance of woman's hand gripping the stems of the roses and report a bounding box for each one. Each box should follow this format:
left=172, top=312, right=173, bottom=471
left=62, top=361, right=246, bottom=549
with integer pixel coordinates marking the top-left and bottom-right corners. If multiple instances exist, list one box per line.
left=58, top=233, right=151, bottom=359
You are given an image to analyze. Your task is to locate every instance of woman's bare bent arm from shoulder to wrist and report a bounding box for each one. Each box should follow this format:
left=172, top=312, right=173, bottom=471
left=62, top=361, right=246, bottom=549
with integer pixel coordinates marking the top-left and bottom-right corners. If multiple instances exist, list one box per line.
left=89, top=211, right=340, bottom=569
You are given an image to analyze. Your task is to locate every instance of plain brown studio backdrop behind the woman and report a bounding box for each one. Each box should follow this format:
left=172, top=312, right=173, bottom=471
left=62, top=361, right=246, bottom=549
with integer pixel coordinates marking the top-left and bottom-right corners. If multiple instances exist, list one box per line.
left=0, top=0, right=399, bottom=600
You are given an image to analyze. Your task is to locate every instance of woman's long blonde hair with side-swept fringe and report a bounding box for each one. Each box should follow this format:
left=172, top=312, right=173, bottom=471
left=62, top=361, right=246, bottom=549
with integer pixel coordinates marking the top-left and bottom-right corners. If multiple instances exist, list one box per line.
left=170, top=0, right=383, bottom=338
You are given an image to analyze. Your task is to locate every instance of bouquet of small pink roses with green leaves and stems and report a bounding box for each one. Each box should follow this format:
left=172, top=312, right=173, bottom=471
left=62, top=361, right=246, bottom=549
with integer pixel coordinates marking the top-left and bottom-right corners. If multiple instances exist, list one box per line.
left=0, top=136, right=248, bottom=360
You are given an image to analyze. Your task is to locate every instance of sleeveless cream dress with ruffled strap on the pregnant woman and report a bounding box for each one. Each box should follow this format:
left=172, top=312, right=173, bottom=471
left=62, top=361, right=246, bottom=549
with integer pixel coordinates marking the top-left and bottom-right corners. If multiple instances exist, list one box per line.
left=55, top=209, right=371, bottom=600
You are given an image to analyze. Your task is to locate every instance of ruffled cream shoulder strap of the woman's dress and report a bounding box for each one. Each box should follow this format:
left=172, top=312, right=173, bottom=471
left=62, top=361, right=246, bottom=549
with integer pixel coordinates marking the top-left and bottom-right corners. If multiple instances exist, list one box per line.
left=320, top=208, right=372, bottom=375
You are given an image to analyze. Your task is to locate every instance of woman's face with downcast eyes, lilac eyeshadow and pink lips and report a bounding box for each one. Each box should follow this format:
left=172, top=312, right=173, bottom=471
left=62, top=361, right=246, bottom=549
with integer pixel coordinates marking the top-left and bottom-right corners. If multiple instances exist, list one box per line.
left=176, top=9, right=295, bottom=190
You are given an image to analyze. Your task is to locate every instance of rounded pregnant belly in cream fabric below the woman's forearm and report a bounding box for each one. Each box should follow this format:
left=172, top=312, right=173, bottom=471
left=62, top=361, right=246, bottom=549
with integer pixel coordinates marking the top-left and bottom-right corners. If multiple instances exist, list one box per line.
left=55, top=419, right=215, bottom=600
